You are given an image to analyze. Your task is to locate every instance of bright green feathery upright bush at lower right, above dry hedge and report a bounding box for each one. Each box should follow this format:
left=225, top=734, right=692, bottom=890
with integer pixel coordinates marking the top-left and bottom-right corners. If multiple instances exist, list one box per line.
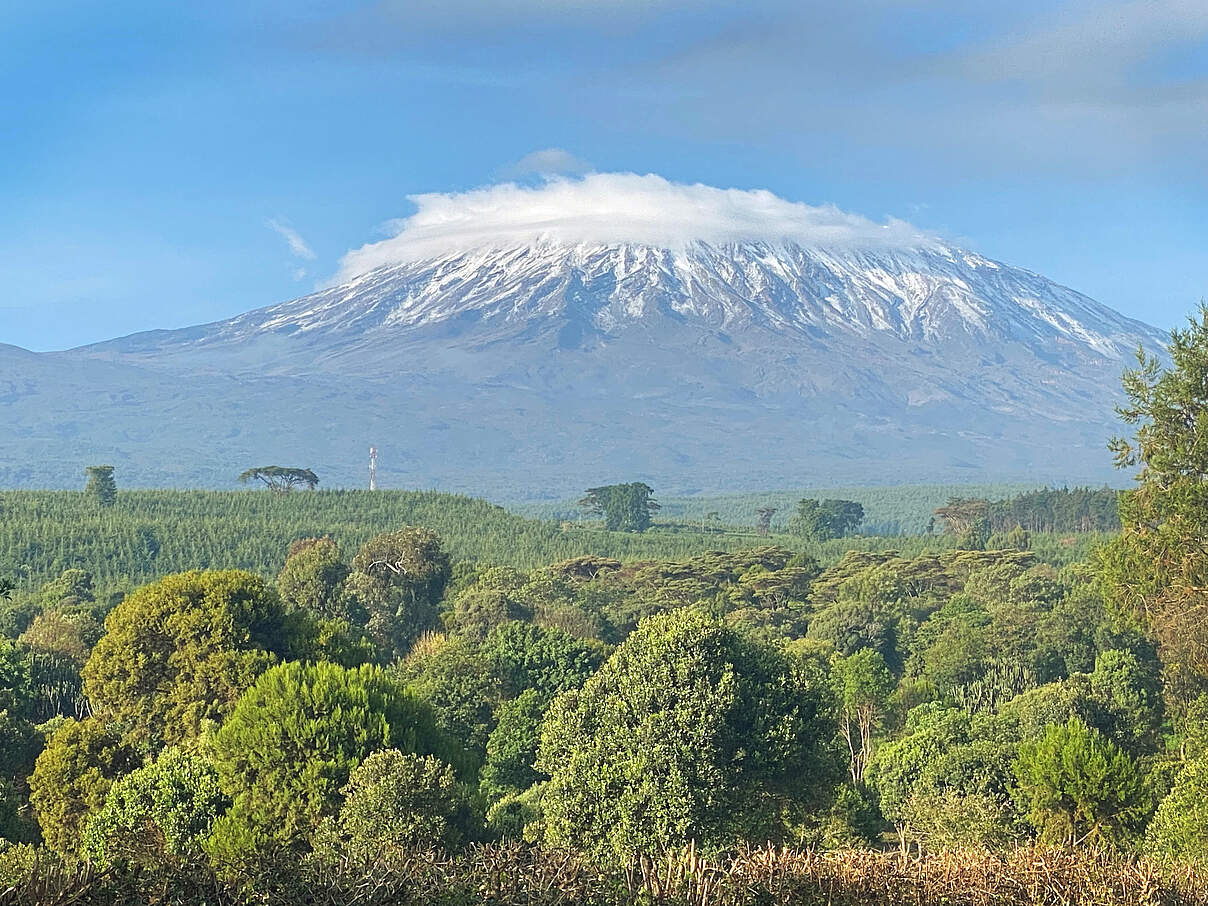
left=1015, top=718, right=1150, bottom=844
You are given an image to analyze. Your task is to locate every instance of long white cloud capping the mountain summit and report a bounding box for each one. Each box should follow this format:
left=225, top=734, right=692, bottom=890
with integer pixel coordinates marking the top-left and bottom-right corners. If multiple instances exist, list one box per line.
left=337, top=173, right=935, bottom=279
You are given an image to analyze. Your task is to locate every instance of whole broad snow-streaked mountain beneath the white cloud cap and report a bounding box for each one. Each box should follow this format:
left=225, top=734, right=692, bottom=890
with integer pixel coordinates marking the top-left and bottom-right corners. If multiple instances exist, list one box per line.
left=0, top=240, right=1165, bottom=499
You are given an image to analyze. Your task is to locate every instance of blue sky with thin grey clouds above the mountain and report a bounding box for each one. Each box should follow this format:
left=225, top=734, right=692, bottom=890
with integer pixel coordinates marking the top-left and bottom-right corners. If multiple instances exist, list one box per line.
left=0, top=0, right=1208, bottom=349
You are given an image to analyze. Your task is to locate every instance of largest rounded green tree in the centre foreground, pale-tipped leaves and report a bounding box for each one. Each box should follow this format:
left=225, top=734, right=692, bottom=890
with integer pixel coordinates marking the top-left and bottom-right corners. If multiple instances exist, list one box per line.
left=538, top=609, right=834, bottom=861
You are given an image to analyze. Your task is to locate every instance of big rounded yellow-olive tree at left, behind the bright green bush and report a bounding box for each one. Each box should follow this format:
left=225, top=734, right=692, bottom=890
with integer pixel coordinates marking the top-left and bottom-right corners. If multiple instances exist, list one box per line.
left=83, top=570, right=291, bottom=749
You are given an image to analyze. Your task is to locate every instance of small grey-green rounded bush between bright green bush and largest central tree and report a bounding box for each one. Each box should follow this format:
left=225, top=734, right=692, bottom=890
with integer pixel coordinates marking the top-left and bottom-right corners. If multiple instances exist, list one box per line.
left=339, top=749, right=472, bottom=861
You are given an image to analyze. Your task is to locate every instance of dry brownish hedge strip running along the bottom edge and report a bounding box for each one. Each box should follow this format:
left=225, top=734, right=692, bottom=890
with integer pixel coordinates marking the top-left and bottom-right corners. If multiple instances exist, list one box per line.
left=0, top=846, right=1208, bottom=906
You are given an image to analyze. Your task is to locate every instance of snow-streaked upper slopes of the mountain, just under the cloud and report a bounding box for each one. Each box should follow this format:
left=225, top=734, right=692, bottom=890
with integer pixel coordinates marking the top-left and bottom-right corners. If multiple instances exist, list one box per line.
left=92, top=243, right=1161, bottom=371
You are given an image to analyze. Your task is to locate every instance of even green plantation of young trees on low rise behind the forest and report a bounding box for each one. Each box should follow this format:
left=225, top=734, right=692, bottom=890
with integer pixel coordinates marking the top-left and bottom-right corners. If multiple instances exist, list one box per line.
left=0, top=489, right=1111, bottom=604
